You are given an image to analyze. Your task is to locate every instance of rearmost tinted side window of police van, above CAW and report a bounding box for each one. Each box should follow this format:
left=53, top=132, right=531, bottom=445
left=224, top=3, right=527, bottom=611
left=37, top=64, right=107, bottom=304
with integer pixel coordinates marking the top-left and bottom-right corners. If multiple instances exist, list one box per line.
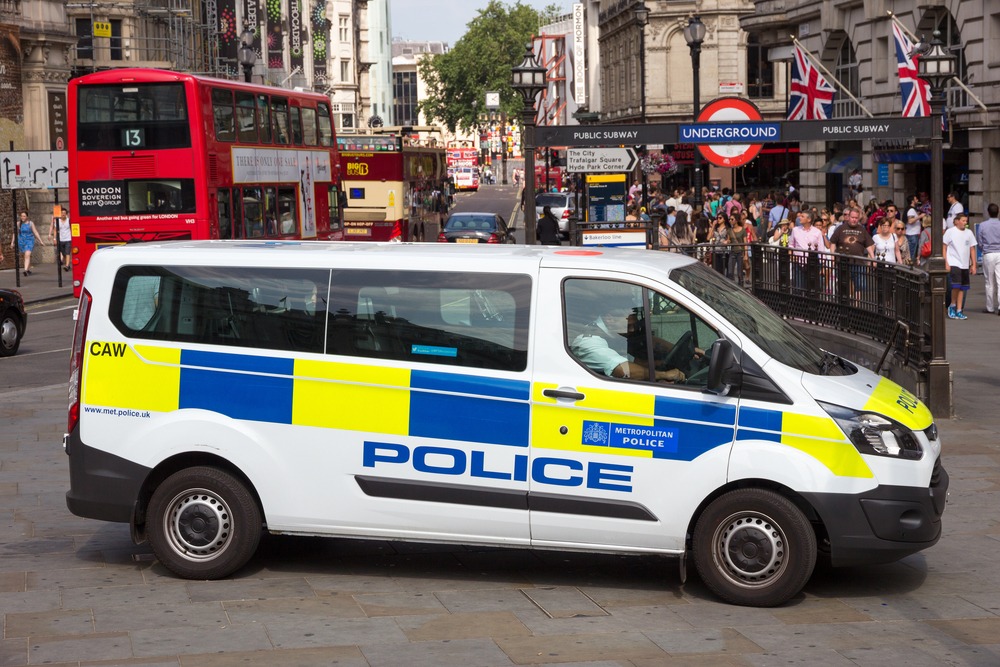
left=111, top=266, right=330, bottom=354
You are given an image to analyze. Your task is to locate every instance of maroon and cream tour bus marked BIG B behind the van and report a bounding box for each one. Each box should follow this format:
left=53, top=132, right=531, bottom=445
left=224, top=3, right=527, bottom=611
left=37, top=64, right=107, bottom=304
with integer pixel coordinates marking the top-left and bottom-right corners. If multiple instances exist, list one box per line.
left=337, top=134, right=446, bottom=241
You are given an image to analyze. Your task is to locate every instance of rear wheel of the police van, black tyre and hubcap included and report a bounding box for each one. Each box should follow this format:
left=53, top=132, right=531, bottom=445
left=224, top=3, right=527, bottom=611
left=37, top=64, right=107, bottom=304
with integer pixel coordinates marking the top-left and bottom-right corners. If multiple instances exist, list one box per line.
left=146, top=466, right=262, bottom=579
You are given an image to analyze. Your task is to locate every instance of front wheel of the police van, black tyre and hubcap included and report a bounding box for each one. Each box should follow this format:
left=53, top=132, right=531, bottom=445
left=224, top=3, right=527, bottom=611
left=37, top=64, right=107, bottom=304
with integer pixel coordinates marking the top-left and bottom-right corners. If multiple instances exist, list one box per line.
left=693, top=489, right=816, bottom=607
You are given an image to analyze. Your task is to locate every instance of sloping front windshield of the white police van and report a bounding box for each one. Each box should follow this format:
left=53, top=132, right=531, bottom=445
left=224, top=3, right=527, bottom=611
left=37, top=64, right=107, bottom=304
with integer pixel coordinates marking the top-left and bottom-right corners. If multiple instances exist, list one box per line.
left=670, top=262, right=856, bottom=375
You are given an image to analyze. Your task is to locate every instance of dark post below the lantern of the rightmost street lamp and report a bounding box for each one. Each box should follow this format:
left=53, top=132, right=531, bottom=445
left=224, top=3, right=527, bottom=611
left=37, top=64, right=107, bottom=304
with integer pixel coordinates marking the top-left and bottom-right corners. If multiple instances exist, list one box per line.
left=927, top=89, right=951, bottom=418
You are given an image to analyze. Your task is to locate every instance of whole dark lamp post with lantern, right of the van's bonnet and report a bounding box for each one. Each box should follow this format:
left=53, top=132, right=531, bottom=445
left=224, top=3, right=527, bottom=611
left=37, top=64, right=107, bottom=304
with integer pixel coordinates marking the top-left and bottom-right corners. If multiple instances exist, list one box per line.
left=914, top=30, right=955, bottom=417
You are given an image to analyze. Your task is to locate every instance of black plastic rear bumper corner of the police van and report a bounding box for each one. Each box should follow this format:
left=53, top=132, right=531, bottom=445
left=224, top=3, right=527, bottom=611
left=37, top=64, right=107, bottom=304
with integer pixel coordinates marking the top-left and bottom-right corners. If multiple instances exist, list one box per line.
left=66, top=426, right=150, bottom=523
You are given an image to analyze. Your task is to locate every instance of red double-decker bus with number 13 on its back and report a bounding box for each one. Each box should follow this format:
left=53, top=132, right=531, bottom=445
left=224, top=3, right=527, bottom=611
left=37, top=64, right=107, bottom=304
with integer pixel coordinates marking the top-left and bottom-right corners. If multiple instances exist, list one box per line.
left=69, top=69, right=343, bottom=294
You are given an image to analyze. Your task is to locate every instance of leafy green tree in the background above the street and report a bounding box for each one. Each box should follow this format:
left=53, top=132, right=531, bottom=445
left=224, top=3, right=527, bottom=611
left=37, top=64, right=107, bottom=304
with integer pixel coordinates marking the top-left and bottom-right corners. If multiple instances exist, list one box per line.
left=420, top=0, right=559, bottom=132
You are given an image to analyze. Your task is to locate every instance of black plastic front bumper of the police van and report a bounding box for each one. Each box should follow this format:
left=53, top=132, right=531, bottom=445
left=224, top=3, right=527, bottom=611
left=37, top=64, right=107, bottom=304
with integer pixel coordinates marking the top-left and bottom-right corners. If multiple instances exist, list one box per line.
left=802, top=460, right=948, bottom=567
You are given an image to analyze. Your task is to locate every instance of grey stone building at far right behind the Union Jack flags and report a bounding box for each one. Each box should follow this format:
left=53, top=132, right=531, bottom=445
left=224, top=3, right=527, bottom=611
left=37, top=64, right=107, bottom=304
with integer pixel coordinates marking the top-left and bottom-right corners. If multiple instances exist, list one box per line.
left=740, top=0, right=1000, bottom=222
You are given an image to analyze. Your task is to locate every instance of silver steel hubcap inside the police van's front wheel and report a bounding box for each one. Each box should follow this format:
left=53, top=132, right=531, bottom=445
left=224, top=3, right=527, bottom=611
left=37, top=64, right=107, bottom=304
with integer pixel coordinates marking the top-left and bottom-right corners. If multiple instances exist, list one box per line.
left=712, top=512, right=788, bottom=588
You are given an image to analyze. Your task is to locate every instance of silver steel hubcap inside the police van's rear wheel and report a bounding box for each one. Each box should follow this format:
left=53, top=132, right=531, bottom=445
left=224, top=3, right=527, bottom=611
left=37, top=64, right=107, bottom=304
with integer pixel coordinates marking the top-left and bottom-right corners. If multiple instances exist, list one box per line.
left=163, top=489, right=233, bottom=563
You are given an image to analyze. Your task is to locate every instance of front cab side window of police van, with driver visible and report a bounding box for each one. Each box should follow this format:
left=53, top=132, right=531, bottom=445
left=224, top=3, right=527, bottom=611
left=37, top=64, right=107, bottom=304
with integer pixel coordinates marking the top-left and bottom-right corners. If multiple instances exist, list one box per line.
left=563, top=278, right=718, bottom=388
